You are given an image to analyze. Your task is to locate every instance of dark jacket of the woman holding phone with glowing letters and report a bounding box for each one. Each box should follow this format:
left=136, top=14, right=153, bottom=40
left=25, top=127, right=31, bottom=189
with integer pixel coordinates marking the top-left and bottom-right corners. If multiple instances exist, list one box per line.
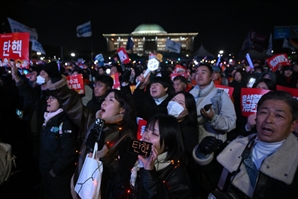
left=133, top=163, right=191, bottom=199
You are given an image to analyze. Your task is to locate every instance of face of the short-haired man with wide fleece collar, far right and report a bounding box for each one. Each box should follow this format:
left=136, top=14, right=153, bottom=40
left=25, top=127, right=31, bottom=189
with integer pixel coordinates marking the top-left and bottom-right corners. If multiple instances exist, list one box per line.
left=256, top=100, right=296, bottom=143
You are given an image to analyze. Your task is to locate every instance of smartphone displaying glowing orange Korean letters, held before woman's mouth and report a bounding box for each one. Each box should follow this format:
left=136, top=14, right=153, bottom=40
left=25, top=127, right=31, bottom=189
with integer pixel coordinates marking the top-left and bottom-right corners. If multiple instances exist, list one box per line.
left=127, top=140, right=152, bottom=157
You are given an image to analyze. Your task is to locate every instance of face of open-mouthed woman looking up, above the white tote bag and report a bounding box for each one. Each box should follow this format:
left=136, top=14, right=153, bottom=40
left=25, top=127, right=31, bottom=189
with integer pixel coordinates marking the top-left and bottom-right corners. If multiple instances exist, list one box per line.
left=101, top=92, right=124, bottom=120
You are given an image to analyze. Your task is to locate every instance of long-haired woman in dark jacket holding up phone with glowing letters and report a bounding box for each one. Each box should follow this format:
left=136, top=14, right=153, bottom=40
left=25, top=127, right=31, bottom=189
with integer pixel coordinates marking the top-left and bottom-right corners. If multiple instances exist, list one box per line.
left=131, top=114, right=191, bottom=199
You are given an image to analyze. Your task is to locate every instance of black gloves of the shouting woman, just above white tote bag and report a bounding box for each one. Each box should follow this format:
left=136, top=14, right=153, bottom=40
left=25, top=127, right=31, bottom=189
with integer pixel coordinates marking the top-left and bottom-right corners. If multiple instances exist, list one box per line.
left=86, top=118, right=105, bottom=153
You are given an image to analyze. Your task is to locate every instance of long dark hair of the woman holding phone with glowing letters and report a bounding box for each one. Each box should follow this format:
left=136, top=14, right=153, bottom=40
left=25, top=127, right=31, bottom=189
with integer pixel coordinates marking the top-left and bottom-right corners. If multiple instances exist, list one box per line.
left=146, top=114, right=185, bottom=161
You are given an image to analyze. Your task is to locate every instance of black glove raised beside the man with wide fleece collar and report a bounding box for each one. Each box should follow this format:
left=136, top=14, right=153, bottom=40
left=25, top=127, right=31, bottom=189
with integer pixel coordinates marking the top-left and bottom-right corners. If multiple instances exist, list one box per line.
left=197, top=136, right=222, bottom=155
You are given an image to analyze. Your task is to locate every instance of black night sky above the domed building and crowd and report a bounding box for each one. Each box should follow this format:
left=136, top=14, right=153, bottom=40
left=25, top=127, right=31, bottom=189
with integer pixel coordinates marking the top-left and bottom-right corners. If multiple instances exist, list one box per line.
left=0, top=1, right=298, bottom=58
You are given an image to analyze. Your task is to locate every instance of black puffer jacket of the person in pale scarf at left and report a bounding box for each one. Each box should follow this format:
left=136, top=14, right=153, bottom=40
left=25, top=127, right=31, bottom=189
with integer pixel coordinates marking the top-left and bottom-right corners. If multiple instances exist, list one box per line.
left=39, top=112, right=79, bottom=176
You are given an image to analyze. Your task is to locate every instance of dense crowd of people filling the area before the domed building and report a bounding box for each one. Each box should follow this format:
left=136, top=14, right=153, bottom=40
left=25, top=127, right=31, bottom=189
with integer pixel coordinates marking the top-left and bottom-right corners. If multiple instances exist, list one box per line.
left=0, top=53, right=298, bottom=199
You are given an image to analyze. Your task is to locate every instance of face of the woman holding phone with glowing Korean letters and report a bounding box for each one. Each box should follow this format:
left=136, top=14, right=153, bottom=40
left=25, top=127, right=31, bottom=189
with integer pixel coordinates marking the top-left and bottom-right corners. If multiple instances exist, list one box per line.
left=143, top=122, right=164, bottom=154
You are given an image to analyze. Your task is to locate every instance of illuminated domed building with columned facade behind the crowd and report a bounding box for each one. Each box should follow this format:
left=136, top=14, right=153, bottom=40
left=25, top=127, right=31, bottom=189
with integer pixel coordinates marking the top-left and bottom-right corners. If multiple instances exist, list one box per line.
left=103, top=24, right=198, bottom=56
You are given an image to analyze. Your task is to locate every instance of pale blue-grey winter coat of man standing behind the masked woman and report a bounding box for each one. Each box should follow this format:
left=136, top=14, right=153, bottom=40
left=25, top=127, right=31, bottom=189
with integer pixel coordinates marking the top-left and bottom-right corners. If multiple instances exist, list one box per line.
left=189, top=82, right=237, bottom=142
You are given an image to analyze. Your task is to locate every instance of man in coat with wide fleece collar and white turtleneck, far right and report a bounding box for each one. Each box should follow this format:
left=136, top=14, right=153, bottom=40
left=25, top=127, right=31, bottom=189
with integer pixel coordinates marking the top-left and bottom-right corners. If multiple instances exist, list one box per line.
left=193, top=91, right=298, bottom=199
